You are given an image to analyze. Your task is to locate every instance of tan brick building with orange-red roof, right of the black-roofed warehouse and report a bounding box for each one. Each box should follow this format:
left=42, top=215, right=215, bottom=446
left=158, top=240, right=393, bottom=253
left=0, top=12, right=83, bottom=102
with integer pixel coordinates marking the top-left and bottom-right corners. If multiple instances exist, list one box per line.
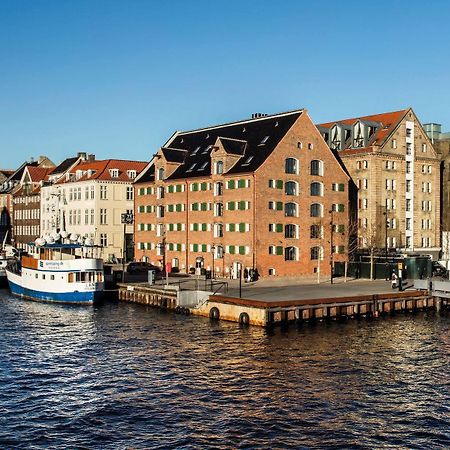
left=317, top=108, right=441, bottom=258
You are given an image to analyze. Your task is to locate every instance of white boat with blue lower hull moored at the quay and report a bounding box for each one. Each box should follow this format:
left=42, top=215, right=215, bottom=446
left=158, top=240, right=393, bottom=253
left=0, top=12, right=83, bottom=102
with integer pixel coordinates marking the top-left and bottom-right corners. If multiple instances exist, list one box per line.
left=6, top=238, right=104, bottom=304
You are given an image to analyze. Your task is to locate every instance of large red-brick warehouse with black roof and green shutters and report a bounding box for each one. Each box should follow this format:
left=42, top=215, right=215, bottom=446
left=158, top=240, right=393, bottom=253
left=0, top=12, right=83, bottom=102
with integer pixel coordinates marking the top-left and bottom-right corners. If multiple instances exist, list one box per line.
left=134, top=110, right=356, bottom=276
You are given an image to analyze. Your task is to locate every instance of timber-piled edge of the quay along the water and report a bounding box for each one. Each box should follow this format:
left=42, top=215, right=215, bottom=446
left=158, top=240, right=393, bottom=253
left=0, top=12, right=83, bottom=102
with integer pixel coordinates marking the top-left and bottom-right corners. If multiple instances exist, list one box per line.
left=118, top=284, right=442, bottom=327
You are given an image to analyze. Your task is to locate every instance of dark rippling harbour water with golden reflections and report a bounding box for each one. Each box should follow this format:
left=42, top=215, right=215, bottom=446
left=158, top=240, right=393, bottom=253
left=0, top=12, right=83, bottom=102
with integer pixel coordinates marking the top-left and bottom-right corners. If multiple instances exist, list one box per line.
left=0, top=293, right=450, bottom=449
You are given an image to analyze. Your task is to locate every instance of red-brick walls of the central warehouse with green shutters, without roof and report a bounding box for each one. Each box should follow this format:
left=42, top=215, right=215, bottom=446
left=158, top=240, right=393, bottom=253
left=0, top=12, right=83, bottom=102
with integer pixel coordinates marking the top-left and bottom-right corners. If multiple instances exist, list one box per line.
left=135, top=111, right=352, bottom=277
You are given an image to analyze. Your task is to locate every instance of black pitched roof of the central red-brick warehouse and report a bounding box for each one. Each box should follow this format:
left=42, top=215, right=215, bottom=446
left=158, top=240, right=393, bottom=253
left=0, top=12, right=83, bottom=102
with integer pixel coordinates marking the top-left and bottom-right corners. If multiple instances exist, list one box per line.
left=158, top=110, right=303, bottom=182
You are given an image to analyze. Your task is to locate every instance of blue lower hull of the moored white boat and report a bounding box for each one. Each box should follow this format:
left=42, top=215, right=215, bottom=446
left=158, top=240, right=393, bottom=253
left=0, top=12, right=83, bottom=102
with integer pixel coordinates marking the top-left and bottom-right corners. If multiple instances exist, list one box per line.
left=8, top=280, right=103, bottom=305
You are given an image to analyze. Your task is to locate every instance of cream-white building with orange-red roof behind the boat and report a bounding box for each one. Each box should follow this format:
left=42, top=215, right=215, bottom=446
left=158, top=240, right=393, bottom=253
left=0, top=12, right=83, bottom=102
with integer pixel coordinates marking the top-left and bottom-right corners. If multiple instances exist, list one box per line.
left=41, top=159, right=147, bottom=262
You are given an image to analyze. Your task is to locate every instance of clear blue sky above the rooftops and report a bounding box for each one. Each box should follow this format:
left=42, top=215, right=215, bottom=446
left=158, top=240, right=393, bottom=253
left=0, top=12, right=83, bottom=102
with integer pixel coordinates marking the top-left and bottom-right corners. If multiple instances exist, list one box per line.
left=0, top=0, right=450, bottom=168
